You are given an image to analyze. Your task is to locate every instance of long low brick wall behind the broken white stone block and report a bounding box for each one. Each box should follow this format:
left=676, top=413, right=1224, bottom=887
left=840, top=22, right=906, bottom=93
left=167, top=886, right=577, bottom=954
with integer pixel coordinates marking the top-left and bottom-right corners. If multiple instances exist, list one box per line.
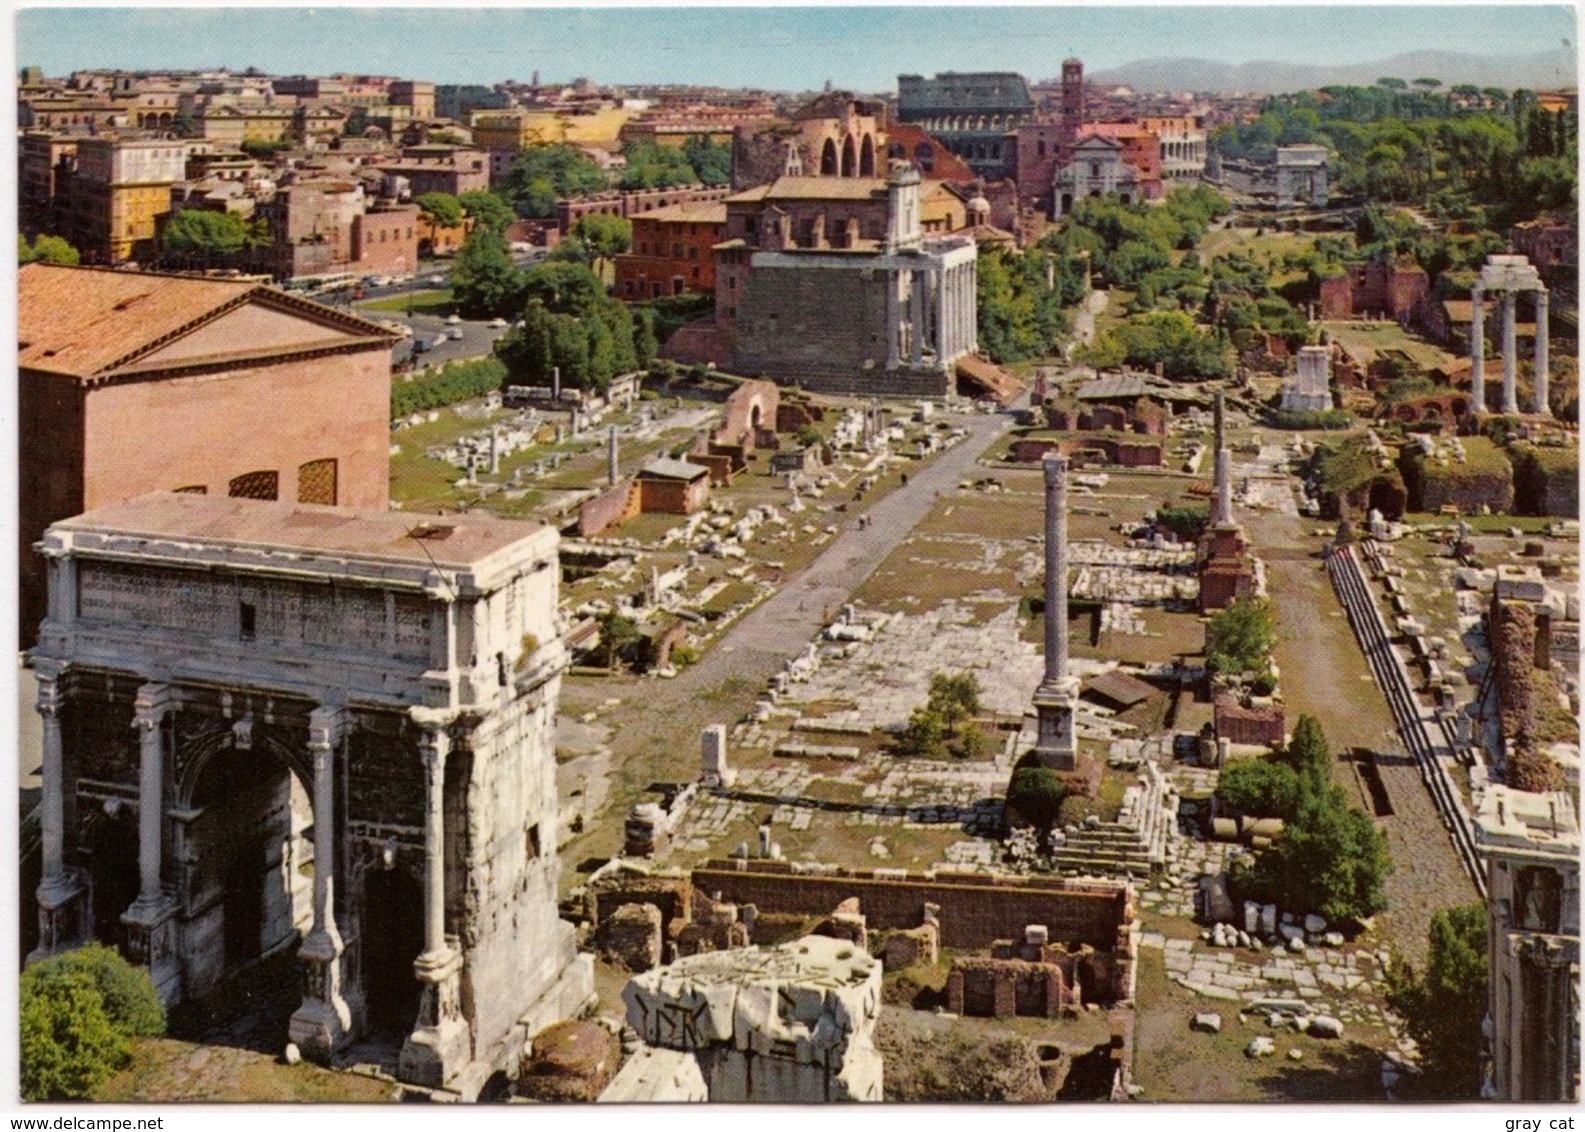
left=693, top=861, right=1132, bottom=951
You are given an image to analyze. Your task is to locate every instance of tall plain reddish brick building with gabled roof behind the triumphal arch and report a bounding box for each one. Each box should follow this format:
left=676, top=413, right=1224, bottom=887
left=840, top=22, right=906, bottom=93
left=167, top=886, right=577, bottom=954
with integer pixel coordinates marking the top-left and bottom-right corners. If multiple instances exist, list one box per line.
left=17, top=263, right=395, bottom=642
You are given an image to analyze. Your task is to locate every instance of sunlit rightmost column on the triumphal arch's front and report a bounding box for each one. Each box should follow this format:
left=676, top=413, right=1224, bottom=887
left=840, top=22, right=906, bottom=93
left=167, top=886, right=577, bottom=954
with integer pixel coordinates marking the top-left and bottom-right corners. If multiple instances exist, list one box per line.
left=399, top=707, right=469, bottom=1088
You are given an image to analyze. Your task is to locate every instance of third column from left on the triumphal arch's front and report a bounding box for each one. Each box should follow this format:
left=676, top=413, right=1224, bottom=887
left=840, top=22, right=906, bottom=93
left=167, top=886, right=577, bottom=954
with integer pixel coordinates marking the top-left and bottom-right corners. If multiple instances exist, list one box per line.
left=287, top=707, right=352, bottom=1062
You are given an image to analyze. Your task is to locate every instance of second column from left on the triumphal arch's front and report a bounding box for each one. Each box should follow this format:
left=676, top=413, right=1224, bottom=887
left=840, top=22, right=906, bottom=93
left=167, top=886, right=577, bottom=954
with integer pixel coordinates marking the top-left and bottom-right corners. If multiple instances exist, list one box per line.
left=120, top=683, right=181, bottom=1004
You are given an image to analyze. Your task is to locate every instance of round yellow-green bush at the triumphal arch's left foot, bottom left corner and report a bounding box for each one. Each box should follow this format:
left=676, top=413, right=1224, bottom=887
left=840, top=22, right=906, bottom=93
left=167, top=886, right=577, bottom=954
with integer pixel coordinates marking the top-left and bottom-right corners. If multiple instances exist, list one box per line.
left=19, top=943, right=165, bottom=1100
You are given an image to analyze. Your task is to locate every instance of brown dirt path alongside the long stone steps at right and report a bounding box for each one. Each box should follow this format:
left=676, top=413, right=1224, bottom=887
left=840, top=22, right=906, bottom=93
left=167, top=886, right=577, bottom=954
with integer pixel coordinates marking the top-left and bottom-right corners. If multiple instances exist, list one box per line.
left=1247, top=514, right=1477, bottom=964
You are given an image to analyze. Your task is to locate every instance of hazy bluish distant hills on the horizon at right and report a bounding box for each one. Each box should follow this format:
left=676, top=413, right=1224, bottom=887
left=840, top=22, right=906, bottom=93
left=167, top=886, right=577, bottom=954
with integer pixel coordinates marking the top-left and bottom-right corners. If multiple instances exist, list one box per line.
left=1086, top=48, right=1579, bottom=94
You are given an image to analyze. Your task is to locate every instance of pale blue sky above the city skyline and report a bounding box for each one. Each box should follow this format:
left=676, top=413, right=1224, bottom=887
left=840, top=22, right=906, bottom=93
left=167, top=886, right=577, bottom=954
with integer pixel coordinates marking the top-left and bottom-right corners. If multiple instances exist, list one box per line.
left=16, top=5, right=1575, bottom=92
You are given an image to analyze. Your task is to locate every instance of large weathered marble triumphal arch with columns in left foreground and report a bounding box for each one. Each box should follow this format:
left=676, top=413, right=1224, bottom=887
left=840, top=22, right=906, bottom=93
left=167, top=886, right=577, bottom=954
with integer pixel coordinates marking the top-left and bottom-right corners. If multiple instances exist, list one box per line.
left=30, top=491, right=594, bottom=1100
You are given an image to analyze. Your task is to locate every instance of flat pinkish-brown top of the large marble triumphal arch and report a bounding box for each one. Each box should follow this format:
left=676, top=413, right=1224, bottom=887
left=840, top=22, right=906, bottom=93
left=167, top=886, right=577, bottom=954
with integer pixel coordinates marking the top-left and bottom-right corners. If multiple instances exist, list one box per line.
left=55, top=491, right=545, bottom=566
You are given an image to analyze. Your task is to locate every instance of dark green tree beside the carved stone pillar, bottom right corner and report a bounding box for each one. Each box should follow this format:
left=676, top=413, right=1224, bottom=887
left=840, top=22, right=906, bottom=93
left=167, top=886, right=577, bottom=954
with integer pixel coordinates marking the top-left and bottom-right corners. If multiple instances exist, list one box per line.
left=1387, top=904, right=1487, bottom=1100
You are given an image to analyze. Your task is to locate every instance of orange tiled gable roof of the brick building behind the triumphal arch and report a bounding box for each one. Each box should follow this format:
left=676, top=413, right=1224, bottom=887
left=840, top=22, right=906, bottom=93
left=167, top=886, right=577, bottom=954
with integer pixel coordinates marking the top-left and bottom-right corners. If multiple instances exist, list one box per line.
left=16, top=263, right=395, bottom=377
